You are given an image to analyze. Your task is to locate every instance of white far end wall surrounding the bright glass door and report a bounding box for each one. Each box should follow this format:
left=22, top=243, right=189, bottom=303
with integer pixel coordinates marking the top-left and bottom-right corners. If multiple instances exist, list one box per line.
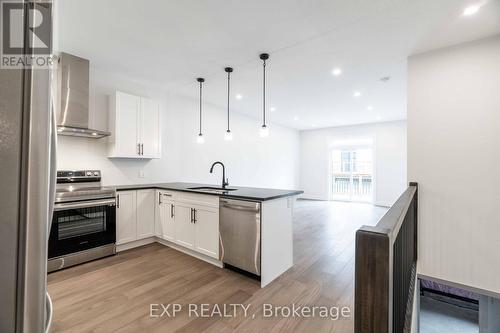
left=300, top=121, right=407, bottom=206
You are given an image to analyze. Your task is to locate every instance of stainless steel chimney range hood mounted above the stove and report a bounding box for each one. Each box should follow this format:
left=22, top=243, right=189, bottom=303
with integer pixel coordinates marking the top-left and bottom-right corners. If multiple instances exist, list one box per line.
left=57, top=52, right=111, bottom=139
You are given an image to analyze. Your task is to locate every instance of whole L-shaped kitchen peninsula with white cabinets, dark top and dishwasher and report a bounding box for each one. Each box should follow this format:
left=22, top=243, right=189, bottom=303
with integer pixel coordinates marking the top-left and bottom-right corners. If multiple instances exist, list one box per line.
left=115, top=183, right=303, bottom=287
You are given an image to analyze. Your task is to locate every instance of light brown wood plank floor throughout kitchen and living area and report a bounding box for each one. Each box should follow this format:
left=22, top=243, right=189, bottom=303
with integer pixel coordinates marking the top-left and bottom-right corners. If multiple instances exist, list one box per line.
left=48, top=200, right=386, bottom=333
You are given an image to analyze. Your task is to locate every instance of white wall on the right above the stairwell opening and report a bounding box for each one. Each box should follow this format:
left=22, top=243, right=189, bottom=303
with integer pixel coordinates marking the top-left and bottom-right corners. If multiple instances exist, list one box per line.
left=408, top=35, right=500, bottom=293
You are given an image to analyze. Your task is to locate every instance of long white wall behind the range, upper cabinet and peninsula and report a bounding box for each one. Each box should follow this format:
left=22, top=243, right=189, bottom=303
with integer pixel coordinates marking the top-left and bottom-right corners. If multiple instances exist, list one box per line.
left=58, top=69, right=300, bottom=189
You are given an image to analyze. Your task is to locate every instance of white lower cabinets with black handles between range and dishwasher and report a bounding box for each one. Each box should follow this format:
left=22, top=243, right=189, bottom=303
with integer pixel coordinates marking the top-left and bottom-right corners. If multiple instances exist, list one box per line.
left=116, top=189, right=219, bottom=259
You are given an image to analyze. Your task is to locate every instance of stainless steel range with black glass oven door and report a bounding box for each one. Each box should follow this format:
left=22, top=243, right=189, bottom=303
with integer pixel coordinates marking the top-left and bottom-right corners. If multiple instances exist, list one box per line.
left=47, top=170, right=116, bottom=272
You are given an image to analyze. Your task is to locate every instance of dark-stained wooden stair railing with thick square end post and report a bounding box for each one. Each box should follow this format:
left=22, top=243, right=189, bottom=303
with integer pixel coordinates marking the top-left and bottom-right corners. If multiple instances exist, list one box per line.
left=354, top=183, right=418, bottom=333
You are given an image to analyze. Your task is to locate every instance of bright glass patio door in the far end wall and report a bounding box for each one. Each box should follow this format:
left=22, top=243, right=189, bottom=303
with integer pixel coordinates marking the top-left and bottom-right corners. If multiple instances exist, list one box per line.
left=330, top=147, right=374, bottom=202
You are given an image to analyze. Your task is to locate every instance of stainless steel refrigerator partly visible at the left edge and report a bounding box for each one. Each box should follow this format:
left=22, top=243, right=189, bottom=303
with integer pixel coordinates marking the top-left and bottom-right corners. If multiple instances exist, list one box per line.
left=0, top=1, right=57, bottom=332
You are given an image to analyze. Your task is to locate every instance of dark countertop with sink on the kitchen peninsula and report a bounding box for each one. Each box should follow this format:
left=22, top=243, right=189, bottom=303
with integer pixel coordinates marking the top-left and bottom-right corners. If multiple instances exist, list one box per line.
left=109, top=183, right=304, bottom=201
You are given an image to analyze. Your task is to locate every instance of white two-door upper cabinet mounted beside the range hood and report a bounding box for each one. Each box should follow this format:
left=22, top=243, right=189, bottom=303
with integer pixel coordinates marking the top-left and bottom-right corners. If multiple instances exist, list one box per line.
left=109, top=91, right=161, bottom=159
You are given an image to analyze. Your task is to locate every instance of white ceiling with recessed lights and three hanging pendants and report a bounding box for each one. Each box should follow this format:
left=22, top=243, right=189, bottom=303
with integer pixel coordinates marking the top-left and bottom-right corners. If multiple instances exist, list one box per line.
left=57, top=0, right=500, bottom=129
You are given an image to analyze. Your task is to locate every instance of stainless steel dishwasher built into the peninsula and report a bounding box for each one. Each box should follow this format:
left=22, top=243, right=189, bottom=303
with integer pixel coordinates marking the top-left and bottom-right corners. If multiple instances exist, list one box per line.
left=219, top=198, right=261, bottom=276
